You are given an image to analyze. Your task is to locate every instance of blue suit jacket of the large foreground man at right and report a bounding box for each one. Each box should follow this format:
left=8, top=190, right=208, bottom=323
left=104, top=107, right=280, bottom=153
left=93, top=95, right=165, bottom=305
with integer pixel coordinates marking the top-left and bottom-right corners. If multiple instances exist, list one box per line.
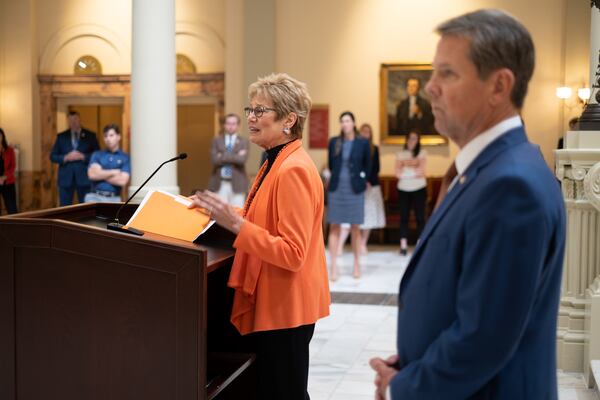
left=390, top=128, right=565, bottom=400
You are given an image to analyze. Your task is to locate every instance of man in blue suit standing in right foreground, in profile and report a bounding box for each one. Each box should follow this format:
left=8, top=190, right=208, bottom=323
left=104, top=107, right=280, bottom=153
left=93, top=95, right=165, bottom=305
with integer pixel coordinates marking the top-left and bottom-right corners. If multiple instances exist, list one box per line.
left=371, top=10, right=565, bottom=400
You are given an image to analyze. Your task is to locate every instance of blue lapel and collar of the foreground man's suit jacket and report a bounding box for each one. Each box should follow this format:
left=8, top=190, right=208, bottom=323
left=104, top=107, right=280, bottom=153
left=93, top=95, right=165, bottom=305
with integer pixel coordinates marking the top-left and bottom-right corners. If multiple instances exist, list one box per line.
left=408, top=127, right=527, bottom=268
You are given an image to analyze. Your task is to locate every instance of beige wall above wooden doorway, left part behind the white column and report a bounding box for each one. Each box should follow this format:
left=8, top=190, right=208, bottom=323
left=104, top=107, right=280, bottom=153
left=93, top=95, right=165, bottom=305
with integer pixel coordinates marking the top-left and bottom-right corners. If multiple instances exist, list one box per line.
left=0, top=0, right=225, bottom=170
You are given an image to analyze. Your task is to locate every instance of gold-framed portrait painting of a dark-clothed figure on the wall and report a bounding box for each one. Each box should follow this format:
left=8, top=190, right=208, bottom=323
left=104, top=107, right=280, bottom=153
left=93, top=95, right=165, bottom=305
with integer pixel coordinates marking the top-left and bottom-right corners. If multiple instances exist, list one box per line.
left=380, top=64, right=448, bottom=146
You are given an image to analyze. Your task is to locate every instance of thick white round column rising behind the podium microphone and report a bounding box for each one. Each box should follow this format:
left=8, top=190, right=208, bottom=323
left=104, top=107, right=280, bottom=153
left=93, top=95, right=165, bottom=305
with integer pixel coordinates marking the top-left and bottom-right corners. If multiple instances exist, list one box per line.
left=129, top=0, right=177, bottom=199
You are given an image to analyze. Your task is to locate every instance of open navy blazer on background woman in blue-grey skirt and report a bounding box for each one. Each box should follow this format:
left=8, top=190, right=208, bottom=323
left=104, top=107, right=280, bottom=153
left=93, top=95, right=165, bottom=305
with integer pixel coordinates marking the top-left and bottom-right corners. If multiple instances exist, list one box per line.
left=328, top=136, right=371, bottom=193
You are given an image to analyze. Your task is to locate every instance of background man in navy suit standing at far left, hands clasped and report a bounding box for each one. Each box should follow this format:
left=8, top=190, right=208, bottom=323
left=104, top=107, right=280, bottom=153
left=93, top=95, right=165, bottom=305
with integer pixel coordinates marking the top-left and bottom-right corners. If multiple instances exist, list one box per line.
left=50, top=111, right=100, bottom=206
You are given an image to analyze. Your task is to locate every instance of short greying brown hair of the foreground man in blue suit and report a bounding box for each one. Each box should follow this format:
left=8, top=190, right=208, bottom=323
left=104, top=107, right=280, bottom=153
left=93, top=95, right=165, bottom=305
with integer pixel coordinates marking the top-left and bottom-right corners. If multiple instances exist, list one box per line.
left=436, top=9, right=535, bottom=109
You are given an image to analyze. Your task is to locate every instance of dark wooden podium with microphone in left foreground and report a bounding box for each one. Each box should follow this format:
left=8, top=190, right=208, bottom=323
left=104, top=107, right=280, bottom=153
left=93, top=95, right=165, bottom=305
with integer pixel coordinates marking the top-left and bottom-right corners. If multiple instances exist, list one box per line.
left=0, top=203, right=254, bottom=400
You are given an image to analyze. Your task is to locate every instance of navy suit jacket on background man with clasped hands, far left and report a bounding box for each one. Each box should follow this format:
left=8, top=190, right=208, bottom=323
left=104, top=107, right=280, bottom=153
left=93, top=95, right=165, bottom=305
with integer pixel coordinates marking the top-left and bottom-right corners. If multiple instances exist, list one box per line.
left=50, top=128, right=100, bottom=187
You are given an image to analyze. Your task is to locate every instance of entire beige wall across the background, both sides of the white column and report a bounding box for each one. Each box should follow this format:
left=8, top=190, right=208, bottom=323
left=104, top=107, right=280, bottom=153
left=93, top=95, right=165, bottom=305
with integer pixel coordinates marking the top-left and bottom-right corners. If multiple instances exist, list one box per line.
left=0, top=0, right=589, bottom=175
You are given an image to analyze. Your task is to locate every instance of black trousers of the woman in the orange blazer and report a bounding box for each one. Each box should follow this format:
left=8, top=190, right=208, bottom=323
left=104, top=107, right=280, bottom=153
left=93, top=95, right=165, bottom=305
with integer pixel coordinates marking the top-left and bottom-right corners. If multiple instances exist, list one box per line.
left=245, top=324, right=315, bottom=400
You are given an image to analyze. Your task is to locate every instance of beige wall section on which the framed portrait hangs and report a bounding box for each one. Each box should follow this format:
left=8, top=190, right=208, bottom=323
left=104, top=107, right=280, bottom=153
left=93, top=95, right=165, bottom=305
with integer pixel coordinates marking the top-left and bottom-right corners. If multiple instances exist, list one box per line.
left=276, top=0, right=589, bottom=175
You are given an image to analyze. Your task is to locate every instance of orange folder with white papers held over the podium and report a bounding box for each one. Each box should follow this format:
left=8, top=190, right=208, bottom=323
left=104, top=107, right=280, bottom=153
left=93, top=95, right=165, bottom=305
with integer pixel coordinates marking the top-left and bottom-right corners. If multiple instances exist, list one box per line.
left=127, top=190, right=215, bottom=242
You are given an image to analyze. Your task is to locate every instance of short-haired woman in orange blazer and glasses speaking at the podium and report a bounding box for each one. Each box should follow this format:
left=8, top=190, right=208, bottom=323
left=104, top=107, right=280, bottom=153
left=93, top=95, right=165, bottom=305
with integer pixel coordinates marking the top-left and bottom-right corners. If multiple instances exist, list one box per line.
left=193, top=74, right=330, bottom=400
